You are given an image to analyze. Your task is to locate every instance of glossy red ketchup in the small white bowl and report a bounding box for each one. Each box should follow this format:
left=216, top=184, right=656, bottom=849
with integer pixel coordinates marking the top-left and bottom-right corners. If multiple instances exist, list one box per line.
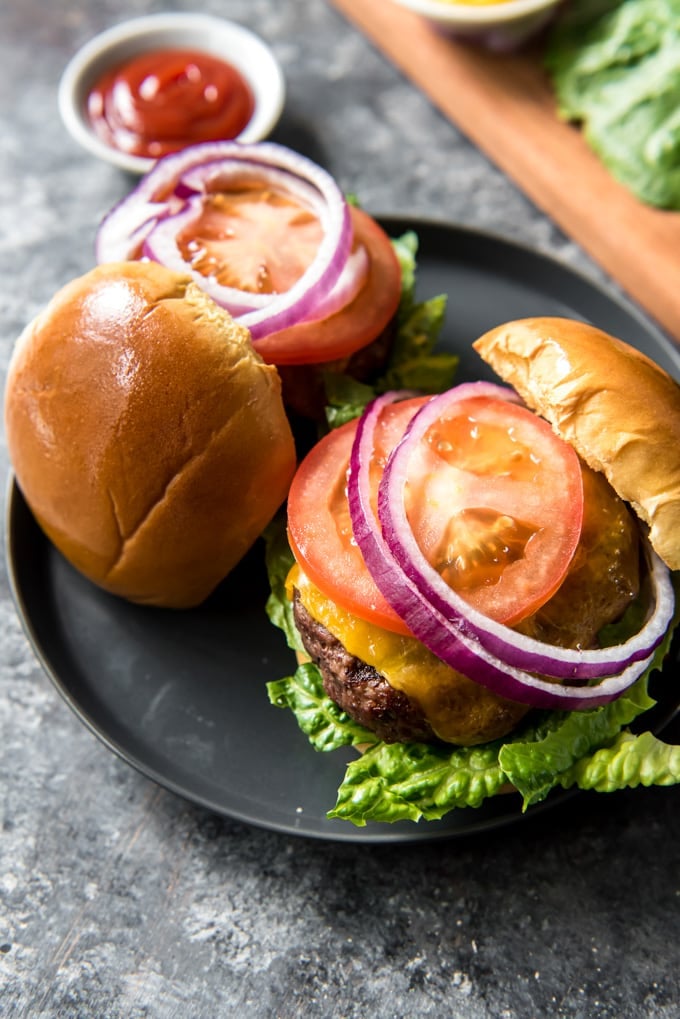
left=88, top=50, right=255, bottom=159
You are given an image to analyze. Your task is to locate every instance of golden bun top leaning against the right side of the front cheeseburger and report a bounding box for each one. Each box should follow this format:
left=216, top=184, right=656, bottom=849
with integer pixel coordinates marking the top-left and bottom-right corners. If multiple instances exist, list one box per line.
left=473, top=318, right=680, bottom=570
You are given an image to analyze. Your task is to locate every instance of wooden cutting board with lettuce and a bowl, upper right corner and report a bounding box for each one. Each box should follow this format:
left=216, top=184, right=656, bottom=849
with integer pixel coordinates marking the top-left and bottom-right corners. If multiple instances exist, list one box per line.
left=331, top=0, right=680, bottom=342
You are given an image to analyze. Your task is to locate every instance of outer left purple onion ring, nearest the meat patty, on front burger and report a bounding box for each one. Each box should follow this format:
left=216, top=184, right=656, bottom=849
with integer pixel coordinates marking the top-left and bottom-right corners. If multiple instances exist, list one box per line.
left=348, top=383, right=672, bottom=710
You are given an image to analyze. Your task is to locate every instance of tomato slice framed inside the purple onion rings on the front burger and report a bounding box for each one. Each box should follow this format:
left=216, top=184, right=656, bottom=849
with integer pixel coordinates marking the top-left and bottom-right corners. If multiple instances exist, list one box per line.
left=405, top=396, right=583, bottom=626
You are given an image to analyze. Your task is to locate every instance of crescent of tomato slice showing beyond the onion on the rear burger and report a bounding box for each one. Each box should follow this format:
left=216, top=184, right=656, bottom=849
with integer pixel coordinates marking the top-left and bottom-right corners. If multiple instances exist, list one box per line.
left=255, top=207, right=402, bottom=365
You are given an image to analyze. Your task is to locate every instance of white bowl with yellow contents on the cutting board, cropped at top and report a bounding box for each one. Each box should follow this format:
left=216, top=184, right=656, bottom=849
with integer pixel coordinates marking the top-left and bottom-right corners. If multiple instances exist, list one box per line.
left=395, top=0, right=563, bottom=50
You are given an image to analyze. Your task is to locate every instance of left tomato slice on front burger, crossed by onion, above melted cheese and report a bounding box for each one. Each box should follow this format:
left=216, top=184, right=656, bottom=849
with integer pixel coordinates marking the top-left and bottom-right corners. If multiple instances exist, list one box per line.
left=287, top=397, right=427, bottom=635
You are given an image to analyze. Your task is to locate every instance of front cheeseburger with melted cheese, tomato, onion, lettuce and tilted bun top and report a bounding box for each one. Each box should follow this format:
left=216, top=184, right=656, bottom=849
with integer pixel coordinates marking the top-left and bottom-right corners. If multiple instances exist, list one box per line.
left=270, top=318, right=680, bottom=824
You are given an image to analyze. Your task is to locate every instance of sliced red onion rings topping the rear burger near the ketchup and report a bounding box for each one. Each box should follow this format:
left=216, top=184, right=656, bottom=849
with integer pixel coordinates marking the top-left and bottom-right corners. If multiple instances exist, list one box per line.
left=97, top=142, right=359, bottom=344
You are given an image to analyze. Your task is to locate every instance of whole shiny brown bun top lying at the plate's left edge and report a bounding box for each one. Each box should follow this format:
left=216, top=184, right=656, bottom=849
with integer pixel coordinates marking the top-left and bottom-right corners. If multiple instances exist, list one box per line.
left=5, top=262, right=296, bottom=608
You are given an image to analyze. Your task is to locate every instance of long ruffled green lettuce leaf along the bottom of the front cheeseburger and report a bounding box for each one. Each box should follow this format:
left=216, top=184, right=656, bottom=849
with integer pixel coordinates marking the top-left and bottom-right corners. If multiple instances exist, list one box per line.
left=328, top=635, right=680, bottom=825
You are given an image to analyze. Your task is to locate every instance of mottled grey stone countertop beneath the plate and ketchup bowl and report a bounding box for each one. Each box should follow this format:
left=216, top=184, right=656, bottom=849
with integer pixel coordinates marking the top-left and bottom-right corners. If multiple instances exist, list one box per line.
left=0, top=0, right=680, bottom=1019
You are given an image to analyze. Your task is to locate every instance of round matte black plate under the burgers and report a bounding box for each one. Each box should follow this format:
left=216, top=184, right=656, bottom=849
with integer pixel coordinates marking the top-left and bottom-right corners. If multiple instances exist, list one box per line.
left=7, top=218, right=680, bottom=843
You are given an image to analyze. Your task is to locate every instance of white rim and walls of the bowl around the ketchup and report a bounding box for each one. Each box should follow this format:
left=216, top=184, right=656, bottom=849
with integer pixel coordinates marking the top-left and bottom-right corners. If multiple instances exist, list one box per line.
left=58, top=12, right=285, bottom=173
